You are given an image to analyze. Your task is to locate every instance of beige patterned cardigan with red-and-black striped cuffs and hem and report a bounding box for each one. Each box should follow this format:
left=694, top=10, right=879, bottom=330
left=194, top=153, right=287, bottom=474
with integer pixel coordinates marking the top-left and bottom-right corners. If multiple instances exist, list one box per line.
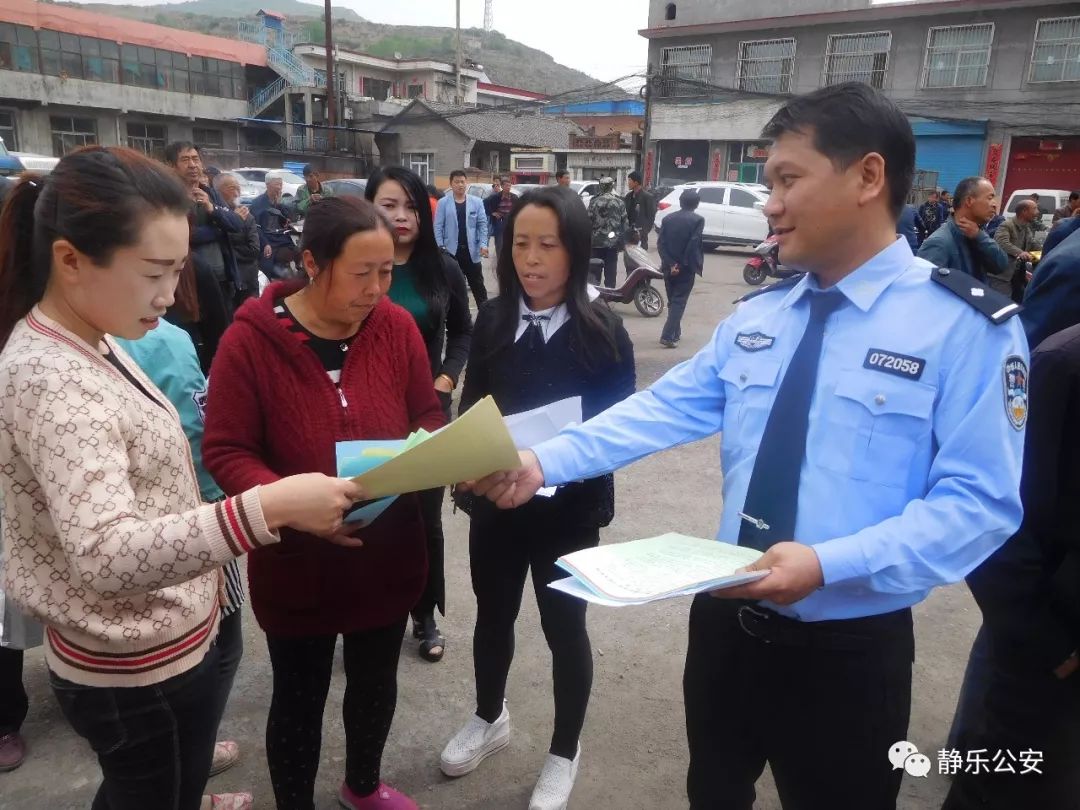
left=0, top=309, right=279, bottom=687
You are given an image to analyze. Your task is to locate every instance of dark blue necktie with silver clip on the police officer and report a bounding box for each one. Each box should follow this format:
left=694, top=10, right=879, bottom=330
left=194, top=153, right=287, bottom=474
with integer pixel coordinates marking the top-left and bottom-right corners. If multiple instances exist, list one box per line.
left=739, top=292, right=843, bottom=551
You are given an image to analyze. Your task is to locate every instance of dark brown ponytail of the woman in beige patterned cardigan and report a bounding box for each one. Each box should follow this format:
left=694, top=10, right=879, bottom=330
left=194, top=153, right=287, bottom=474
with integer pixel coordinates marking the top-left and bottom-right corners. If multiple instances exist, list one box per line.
left=0, top=174, right=49, bottom=348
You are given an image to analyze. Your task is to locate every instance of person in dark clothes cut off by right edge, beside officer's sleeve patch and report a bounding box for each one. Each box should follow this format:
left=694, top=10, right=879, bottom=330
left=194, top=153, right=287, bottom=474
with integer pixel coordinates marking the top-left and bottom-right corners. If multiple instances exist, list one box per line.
left=943, top=321, right=1080, bottom=810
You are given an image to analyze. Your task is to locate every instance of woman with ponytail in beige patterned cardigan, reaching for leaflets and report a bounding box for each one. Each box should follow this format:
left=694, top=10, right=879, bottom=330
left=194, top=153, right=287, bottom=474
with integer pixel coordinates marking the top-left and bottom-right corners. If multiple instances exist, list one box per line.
left=0, top=147, right=359, bottom=810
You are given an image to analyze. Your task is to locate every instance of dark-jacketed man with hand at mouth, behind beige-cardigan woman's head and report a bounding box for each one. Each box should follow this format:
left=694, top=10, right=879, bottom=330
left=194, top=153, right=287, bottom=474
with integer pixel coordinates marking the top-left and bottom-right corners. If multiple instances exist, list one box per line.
left=165, top=140, right=244, bottom=312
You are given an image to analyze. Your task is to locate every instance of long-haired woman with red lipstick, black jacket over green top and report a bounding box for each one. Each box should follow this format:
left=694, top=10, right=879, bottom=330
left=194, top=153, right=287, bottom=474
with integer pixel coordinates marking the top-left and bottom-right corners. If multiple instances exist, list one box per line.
left=365, top=166, right=472, bottom=662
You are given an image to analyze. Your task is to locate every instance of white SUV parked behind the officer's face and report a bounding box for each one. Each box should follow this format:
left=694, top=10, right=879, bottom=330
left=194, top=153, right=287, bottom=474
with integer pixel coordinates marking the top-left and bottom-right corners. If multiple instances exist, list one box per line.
left=656, top=180, right=769, bottom=247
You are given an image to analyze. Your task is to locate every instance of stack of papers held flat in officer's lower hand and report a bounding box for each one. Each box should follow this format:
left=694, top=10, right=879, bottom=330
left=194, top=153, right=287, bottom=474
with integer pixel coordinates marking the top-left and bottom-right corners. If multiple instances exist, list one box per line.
left=549, top=534, right=769, bottom=607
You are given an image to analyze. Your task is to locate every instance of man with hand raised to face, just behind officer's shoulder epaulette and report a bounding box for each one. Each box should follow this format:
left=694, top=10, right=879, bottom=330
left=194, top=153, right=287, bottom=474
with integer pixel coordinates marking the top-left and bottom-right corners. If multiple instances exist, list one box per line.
left=918, top=177, right=1009, bottom=282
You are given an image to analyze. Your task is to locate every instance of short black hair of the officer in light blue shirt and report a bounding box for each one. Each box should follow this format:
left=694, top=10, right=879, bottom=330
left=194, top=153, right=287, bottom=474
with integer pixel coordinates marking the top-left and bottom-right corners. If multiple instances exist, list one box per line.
left=761, top=82, right=915, bottom=216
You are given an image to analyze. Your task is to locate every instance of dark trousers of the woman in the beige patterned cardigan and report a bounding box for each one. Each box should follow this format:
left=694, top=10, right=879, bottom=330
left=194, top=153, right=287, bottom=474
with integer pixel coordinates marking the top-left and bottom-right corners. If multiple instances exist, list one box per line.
left=50, top=645, right=220, bottom=810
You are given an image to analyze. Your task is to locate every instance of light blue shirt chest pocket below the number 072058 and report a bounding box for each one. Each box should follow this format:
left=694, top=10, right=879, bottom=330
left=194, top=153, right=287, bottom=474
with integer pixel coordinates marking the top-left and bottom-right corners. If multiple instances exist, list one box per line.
left=808, top=370, right=937, bottom=488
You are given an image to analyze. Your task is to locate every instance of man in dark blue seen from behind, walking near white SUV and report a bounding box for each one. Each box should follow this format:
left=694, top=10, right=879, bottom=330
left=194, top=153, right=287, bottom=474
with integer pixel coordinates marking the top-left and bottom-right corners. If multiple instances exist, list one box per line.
left=657, top=189, right=705, bottom=349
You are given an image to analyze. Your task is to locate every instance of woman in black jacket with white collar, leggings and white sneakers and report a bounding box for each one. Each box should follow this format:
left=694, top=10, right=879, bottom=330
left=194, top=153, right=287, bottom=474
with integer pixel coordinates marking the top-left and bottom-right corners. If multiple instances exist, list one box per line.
left=441, top=187, right=635, bottom=810
